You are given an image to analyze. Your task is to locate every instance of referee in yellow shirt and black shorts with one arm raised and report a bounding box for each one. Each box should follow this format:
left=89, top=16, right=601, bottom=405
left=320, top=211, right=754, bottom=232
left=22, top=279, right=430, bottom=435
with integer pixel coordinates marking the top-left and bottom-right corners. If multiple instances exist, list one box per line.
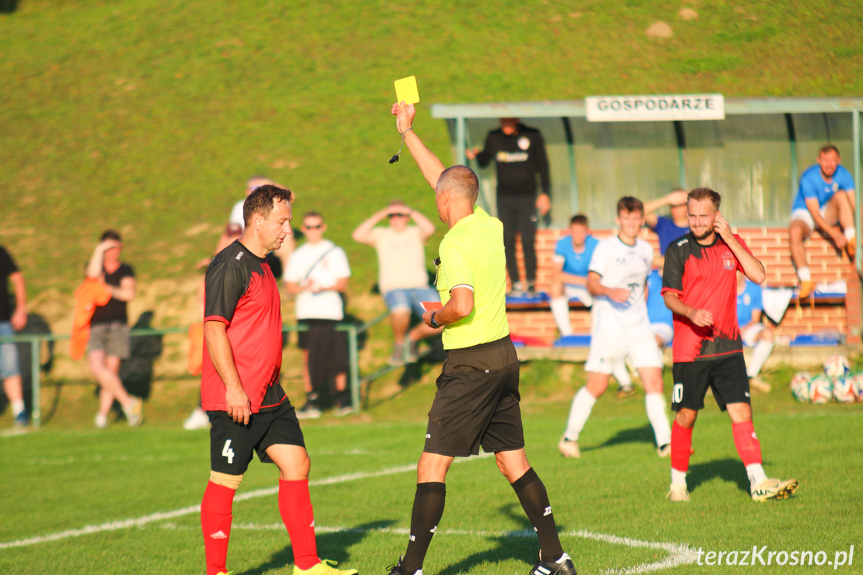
left=390, top=103, right=576, bottom=575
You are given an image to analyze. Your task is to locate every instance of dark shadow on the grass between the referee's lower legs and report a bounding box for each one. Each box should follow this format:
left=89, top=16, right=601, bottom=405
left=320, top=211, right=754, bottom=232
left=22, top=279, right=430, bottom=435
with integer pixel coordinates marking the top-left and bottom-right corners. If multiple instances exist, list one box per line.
left=432, top=504, right=539, bottom=575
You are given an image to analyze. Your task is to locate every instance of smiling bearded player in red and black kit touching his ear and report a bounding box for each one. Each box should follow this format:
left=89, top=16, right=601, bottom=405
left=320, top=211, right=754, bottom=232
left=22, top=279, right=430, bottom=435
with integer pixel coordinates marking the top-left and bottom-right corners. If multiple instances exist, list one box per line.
left=662, top=188, right=797, bottom=501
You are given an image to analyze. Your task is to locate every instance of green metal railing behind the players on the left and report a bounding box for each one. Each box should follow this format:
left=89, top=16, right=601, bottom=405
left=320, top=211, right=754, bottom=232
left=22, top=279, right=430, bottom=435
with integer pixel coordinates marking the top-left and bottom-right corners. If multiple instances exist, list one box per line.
left=0, top=312, right=390, bottom=427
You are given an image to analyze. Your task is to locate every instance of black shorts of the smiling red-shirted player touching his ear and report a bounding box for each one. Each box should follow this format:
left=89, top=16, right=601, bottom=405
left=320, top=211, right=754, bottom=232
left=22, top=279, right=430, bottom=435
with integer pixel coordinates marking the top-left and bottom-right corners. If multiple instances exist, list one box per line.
left=671, top=352, right=749, bottom=411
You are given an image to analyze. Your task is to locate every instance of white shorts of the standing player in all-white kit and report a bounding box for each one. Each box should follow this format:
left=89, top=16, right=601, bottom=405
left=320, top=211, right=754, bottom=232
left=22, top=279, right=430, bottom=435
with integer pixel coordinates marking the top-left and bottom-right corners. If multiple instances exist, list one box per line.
left=584, top=324, right=662, bottom=373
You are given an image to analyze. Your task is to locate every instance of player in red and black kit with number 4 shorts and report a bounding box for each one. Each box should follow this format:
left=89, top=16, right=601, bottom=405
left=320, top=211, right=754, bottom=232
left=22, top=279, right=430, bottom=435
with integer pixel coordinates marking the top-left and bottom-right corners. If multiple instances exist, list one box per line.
left=201, top=185, right=357, bottom=575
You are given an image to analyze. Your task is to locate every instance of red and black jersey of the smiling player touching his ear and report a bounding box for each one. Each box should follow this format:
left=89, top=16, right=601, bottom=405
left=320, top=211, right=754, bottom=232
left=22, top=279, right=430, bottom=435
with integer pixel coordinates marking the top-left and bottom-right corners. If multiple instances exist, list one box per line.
left=662, top=233, right=751, bottom=363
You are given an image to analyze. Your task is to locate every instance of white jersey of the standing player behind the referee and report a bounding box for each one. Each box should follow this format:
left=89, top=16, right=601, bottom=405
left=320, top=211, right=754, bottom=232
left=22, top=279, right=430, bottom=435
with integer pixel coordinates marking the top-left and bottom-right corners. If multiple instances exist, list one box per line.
left=590, top=235, right=653, bottom=333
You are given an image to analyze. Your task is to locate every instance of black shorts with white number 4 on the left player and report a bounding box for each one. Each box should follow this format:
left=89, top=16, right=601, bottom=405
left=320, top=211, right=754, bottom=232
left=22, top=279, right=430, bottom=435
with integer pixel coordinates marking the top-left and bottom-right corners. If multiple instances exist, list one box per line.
left=207, top=397, right=306, bottom=475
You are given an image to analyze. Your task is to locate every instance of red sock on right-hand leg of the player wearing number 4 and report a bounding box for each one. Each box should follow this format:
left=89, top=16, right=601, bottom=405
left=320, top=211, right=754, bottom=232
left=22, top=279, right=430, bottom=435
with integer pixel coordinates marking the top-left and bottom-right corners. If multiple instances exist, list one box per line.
left=279, top=479, right=321, bottom=569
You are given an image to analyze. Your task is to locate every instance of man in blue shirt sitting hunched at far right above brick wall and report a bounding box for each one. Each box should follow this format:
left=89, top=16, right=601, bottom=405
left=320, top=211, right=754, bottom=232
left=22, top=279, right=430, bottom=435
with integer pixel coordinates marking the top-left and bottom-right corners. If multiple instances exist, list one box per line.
left=788, top=144, right=855, bottom=298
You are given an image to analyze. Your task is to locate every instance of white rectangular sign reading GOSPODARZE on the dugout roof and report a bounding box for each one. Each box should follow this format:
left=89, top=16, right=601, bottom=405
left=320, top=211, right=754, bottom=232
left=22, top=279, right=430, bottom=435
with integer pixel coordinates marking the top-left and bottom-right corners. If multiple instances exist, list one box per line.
left=585, top=94, right=725, bottom=122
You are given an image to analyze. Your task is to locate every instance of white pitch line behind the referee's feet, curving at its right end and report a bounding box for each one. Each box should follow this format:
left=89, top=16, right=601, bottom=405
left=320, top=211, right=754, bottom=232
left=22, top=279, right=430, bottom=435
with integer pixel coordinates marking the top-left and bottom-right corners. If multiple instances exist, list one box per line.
left=162, top=523, right=698, bottom=575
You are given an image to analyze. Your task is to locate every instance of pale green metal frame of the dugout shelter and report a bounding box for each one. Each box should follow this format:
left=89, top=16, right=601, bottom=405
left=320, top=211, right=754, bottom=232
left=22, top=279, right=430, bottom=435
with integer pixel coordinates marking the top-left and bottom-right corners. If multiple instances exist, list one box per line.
left=431, top=98, right=863, bottom=269
